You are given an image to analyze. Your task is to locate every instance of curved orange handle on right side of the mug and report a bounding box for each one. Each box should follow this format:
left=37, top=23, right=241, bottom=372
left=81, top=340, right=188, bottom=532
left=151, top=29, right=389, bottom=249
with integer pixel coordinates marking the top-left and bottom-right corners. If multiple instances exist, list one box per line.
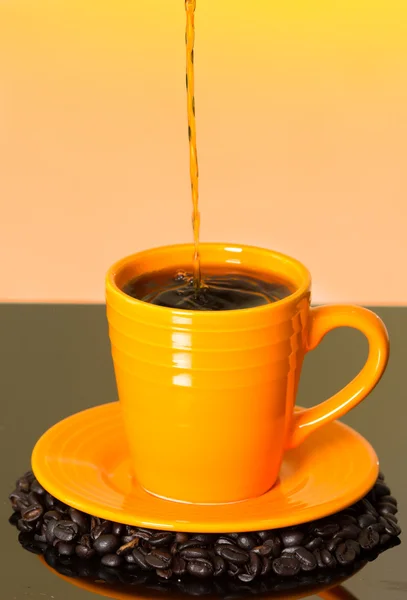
left=287, top=305, right=389, bottom=449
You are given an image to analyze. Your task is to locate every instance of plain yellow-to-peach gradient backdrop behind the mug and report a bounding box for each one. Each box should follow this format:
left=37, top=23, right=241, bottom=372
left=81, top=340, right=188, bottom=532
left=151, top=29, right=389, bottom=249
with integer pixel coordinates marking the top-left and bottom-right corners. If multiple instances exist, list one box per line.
left=0, top=0, right=407, bottom=304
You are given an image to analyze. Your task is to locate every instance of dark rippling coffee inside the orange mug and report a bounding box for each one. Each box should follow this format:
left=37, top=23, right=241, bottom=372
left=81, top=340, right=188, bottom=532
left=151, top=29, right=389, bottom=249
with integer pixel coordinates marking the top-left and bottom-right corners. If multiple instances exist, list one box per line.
left=122, top=265, right=295, bottom=311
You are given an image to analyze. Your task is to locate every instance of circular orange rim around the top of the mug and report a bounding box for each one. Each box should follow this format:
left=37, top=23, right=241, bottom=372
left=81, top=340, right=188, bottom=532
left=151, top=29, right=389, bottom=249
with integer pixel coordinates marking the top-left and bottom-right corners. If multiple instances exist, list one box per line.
left=105, top=242, right=311, bottom=319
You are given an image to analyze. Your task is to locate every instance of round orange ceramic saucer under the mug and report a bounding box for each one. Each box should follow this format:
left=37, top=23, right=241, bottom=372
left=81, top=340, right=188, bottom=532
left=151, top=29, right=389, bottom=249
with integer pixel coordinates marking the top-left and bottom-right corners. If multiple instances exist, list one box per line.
left=32, top=402, right=379, bottom=533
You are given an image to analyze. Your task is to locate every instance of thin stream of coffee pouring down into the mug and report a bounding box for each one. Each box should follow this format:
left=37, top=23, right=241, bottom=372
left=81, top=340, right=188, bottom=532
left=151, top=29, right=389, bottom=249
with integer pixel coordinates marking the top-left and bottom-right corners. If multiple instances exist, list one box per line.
left=185, top=0, right=201, bottom=290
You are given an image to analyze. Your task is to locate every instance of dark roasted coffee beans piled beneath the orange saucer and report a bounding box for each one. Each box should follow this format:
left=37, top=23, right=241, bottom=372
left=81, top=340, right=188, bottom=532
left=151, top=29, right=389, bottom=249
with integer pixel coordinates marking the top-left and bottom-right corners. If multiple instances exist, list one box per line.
left=10, top=472, right=401, bottom=584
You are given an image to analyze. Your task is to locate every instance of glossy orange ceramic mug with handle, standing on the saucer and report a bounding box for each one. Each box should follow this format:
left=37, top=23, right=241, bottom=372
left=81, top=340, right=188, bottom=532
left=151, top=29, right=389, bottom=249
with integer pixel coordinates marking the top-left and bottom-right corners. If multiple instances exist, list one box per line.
left=106, top=244, right=388, bottom=503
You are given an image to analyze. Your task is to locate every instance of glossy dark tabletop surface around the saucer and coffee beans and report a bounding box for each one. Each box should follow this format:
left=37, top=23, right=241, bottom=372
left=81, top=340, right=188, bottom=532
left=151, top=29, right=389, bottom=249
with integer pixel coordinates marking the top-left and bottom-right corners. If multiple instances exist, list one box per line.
left=0, top=304, right=407, bottom=600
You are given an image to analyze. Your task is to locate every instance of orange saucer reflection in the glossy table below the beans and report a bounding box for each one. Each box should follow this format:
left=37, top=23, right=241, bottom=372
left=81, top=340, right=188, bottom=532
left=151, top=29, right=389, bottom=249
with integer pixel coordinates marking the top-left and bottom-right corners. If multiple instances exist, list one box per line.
left=39, top=556, right=364, bottom=600
